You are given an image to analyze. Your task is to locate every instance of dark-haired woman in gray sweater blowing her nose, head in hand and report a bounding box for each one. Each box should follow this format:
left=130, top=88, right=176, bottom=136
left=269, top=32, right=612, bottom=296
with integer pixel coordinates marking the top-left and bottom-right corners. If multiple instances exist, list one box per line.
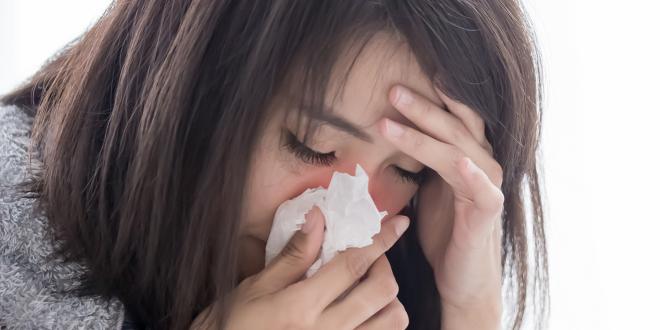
left=2, top=0, right=547, bottom=329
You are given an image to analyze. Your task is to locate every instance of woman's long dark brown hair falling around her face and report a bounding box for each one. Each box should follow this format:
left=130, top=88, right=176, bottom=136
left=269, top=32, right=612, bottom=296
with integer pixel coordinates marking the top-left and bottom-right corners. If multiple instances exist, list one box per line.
left=2, top=0, right=548, bottom=329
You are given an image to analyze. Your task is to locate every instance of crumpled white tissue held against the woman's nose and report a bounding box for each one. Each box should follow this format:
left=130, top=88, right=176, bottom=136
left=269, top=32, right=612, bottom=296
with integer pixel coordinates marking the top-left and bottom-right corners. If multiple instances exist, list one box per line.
left=266, top=164, right=387, bottom=277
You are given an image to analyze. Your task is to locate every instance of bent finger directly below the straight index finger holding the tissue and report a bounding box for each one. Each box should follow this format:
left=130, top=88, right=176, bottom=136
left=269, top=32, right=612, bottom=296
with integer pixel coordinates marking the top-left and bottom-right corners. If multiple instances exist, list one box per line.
left=323, top=255, right=399, bottom=329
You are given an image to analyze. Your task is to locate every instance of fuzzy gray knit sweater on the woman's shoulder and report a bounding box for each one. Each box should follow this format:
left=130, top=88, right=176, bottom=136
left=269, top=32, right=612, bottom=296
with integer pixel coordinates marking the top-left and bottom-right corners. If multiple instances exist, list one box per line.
left=0, top=106, right=124, bottom=329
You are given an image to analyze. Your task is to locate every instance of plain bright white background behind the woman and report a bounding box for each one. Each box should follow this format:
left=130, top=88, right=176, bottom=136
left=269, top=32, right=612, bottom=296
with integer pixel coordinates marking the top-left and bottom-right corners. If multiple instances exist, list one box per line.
left=0, top=0, right=660, bottom=330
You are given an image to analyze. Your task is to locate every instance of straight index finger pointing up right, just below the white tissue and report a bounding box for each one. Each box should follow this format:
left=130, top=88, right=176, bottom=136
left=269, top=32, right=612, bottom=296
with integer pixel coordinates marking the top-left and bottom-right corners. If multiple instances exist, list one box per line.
left=291, top=216, right=409, bottom=310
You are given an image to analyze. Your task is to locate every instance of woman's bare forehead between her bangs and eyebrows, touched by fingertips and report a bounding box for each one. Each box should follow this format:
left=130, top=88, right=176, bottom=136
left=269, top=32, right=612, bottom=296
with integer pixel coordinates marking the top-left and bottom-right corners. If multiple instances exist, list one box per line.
left=326, top=33, right=444, bottom=129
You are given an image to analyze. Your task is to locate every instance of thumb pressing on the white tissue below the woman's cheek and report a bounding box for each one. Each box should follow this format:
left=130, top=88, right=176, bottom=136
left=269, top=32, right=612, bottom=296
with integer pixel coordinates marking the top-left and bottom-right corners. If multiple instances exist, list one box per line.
left=258, top=206, right=325, bottom=293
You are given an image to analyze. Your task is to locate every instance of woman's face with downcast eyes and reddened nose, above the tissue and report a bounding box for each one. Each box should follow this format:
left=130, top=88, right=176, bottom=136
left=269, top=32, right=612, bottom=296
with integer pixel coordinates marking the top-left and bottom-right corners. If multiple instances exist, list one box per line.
left=241, top=35, right=442, bottom=274
